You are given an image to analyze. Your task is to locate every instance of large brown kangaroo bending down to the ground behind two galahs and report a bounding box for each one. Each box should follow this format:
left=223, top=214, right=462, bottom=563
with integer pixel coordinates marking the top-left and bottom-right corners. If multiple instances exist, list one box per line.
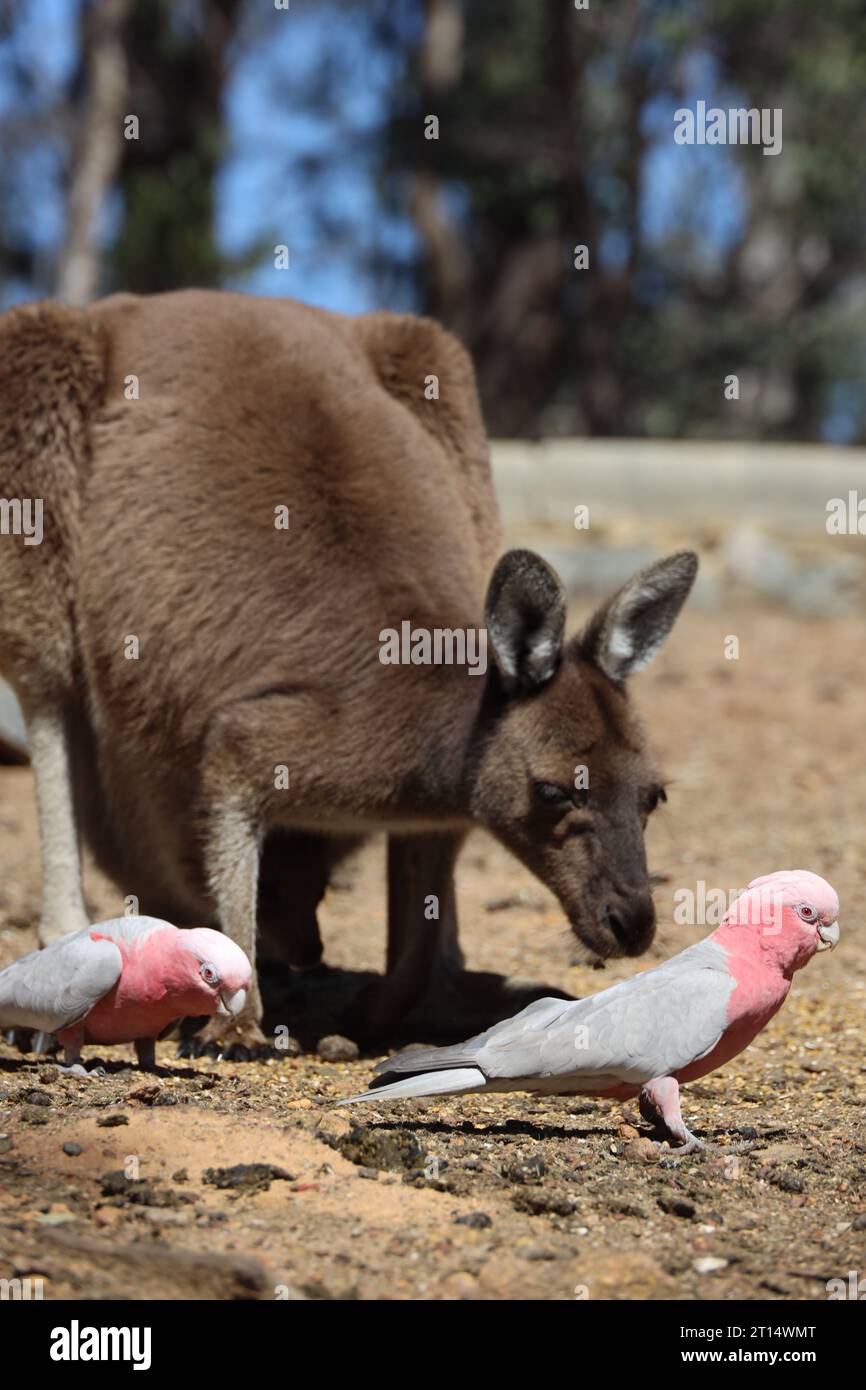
left=0, top=291, right=696, bottom=1056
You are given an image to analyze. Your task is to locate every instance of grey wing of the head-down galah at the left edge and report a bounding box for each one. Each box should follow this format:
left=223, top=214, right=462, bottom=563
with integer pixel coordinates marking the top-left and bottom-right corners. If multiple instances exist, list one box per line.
left=0, top=927, right=122, bottom=1033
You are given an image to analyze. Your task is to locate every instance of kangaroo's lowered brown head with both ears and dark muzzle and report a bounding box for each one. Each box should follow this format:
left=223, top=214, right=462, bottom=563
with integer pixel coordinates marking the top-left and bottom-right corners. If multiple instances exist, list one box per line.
left=473, top=550, right=698, bottom=956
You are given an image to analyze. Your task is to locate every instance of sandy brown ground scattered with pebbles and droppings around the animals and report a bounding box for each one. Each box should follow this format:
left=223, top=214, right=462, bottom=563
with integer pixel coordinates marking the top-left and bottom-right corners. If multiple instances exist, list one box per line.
left=0, top=609, right=866, bottom=1300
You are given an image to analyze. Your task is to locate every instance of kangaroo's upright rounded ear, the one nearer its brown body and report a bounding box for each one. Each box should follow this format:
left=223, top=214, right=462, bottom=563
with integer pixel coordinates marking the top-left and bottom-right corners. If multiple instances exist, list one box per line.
left=485, top=550, right=566, bottom=692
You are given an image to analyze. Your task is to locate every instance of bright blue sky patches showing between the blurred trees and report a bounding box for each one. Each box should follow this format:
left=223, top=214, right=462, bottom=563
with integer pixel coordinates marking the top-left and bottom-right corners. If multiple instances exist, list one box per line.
left=0, top=0, right=744, bottom=313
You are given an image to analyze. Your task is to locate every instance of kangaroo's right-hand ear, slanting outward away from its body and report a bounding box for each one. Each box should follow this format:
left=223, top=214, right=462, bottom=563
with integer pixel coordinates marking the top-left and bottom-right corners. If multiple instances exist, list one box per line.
left=577, top=550, right=698, bottom=682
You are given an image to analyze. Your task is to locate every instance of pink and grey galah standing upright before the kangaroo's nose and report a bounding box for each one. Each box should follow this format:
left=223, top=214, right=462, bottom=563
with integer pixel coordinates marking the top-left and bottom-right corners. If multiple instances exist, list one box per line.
left=341, top=869, right=840, bottom=1154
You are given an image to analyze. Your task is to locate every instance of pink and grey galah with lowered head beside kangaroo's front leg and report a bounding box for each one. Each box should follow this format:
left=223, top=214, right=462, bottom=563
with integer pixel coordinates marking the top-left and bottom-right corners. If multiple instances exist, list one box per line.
left=0, top=917, right=252, bottom=1072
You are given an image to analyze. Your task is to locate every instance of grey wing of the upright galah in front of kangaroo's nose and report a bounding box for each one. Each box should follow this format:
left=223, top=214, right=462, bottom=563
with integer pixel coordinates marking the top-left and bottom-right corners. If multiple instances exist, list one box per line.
left=377, top=940, right=734, bottom=1091
